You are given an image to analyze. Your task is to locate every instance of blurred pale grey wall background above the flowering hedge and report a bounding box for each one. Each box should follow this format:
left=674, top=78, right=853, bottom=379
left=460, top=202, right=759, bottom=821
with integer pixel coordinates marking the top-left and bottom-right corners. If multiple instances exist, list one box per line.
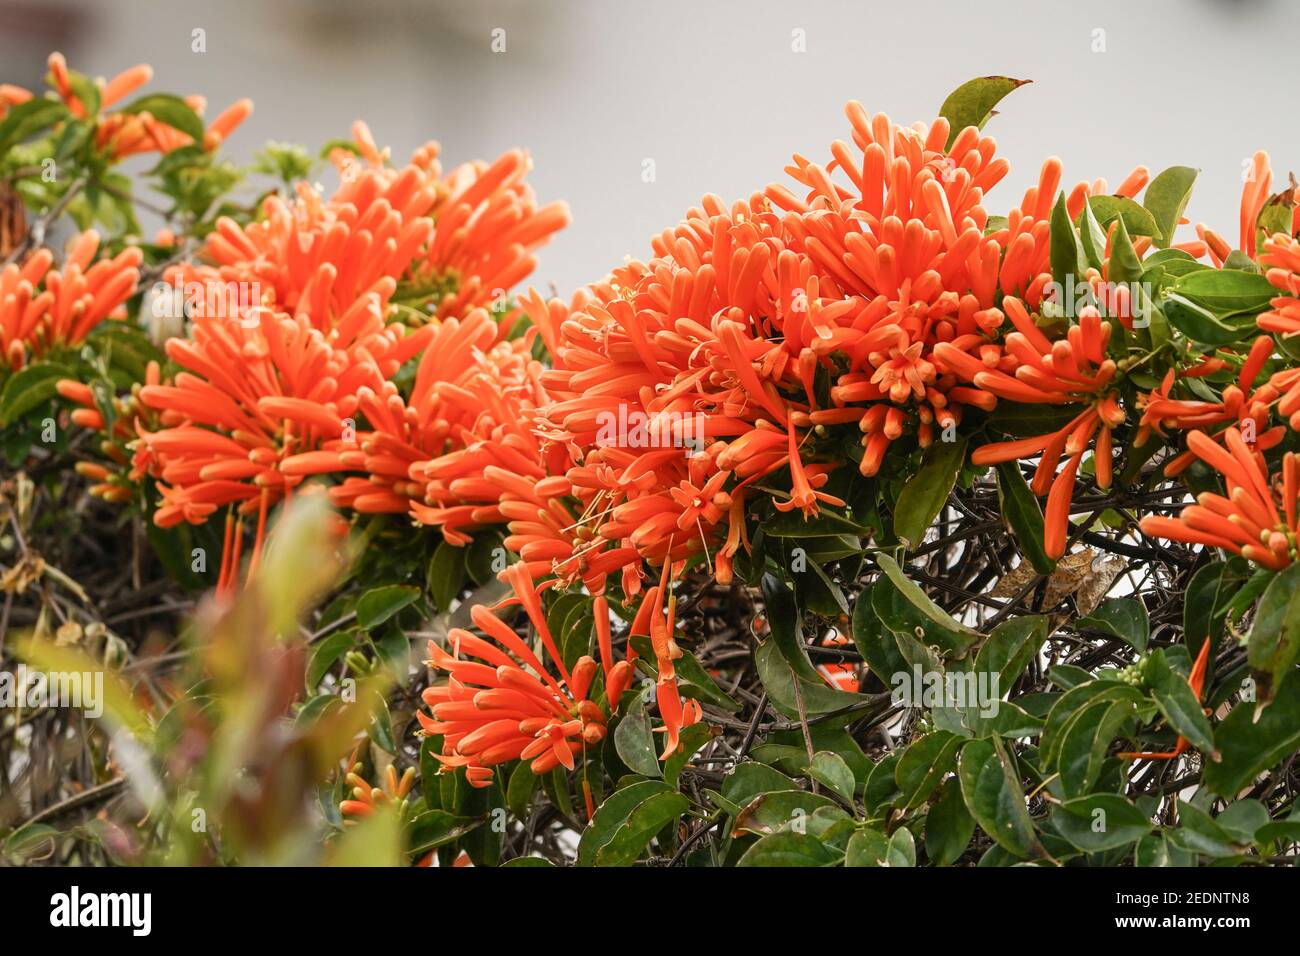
left=0, top=0, right=1300, bottom=294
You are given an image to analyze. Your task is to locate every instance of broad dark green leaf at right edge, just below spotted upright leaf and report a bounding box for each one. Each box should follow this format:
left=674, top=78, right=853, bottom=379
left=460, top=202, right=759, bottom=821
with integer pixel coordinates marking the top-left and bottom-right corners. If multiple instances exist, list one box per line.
left=1205, top=671, right=1300, bottom=796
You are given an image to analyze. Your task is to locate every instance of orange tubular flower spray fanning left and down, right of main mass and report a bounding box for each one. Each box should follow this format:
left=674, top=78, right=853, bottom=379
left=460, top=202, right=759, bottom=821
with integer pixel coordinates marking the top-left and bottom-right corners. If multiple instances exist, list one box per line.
left=936, top=297, right=1125, bottom=558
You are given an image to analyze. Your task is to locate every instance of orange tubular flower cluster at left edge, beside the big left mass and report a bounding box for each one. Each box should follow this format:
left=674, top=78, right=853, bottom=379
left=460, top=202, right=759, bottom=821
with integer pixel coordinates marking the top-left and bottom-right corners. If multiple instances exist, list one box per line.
left=0, top=229, right=142, bottom=369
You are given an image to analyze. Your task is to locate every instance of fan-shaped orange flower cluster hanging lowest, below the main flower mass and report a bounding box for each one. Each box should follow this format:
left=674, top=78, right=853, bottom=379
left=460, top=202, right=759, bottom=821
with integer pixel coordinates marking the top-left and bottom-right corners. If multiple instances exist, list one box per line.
left=416, top=564, right=632, bottom=787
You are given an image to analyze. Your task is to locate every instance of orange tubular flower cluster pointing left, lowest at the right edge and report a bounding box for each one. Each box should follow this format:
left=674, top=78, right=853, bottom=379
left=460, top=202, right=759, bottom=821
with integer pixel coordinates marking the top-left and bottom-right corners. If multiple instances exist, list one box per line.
left=1140, top=425, right=1300, bottom=571
